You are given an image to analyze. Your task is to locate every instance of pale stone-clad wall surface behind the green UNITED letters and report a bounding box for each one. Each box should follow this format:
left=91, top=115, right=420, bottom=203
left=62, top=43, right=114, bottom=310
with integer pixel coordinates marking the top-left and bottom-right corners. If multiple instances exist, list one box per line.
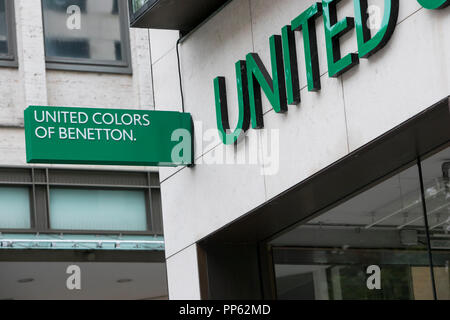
left=154, top=0, right=450, bottom=298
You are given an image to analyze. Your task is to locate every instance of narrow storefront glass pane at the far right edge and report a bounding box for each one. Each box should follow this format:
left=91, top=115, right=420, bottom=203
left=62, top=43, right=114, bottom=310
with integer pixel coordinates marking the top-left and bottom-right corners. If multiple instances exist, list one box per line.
left=422, top=148, right=450, bottom=300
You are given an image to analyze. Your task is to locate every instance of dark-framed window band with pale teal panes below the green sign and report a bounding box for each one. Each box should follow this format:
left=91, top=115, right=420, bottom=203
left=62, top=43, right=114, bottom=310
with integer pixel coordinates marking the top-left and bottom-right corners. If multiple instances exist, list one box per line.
left=0, top=168, right=163, bottom=236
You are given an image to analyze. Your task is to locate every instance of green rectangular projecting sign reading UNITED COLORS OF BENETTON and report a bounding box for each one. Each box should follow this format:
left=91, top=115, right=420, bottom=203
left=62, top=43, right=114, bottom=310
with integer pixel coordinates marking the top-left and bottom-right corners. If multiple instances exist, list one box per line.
left=25, top=106, right=194, bottom=166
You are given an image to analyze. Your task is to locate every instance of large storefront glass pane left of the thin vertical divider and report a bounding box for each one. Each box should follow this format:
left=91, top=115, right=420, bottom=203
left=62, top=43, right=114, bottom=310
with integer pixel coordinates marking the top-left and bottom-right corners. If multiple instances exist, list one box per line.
left=272, top=165, right=433, bottom=300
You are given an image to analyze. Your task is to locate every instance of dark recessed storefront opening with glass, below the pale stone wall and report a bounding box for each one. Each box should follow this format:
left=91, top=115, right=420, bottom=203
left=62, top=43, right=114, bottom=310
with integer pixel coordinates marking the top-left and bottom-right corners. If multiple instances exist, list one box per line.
left=198, top=98, right=450, bottom=300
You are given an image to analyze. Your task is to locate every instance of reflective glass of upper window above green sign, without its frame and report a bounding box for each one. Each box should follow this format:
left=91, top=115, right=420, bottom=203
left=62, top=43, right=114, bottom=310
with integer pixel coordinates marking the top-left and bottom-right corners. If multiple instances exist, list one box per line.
left=43, top=0, right=124, bottom=63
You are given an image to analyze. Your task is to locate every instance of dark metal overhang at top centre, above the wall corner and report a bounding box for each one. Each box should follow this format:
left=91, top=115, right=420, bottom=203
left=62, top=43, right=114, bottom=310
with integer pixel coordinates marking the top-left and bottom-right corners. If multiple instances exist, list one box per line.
left=129, top=0, right=230, bottom=35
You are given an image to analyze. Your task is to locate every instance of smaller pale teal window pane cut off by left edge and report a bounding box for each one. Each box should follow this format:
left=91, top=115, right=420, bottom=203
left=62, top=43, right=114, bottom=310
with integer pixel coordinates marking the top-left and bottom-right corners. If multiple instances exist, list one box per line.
left=0, top=187, right=31, bottom=229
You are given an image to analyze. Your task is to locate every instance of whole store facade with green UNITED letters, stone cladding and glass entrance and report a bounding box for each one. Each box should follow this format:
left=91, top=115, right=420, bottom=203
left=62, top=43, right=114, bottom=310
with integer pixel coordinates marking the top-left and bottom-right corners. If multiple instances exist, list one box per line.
left=133, top=0, right=450, bottom=300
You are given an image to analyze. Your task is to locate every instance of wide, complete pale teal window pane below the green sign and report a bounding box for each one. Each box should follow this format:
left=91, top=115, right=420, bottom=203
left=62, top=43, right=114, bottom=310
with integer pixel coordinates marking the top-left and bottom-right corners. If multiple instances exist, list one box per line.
left=50, top=188, right=147, bottom=231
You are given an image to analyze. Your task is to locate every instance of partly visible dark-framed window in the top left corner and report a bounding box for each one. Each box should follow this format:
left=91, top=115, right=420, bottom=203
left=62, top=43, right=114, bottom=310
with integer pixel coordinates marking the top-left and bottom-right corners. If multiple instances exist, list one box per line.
left=0, top=0, right=17, bottom=67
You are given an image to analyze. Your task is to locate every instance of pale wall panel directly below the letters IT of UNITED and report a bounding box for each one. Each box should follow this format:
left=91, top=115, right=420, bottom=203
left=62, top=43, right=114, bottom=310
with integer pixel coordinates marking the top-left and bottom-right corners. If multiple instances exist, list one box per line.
left=262, top=75, right=348, bottom=199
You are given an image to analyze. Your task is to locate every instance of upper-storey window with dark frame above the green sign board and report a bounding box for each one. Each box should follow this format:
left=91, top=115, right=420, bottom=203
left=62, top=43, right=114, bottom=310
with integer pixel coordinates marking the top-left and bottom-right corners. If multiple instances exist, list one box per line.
left=42, top=0, right=131, bottom=73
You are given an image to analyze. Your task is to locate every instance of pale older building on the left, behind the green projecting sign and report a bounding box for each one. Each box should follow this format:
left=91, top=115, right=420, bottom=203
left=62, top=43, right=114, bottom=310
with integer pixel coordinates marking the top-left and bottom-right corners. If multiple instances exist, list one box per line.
left=0, top=0, right=168, bottom=299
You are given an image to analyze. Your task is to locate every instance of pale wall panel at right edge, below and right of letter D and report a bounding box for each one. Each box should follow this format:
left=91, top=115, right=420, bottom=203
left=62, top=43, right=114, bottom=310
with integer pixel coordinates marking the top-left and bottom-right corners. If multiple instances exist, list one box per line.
left=343, top=9, right=450, bottom=150
